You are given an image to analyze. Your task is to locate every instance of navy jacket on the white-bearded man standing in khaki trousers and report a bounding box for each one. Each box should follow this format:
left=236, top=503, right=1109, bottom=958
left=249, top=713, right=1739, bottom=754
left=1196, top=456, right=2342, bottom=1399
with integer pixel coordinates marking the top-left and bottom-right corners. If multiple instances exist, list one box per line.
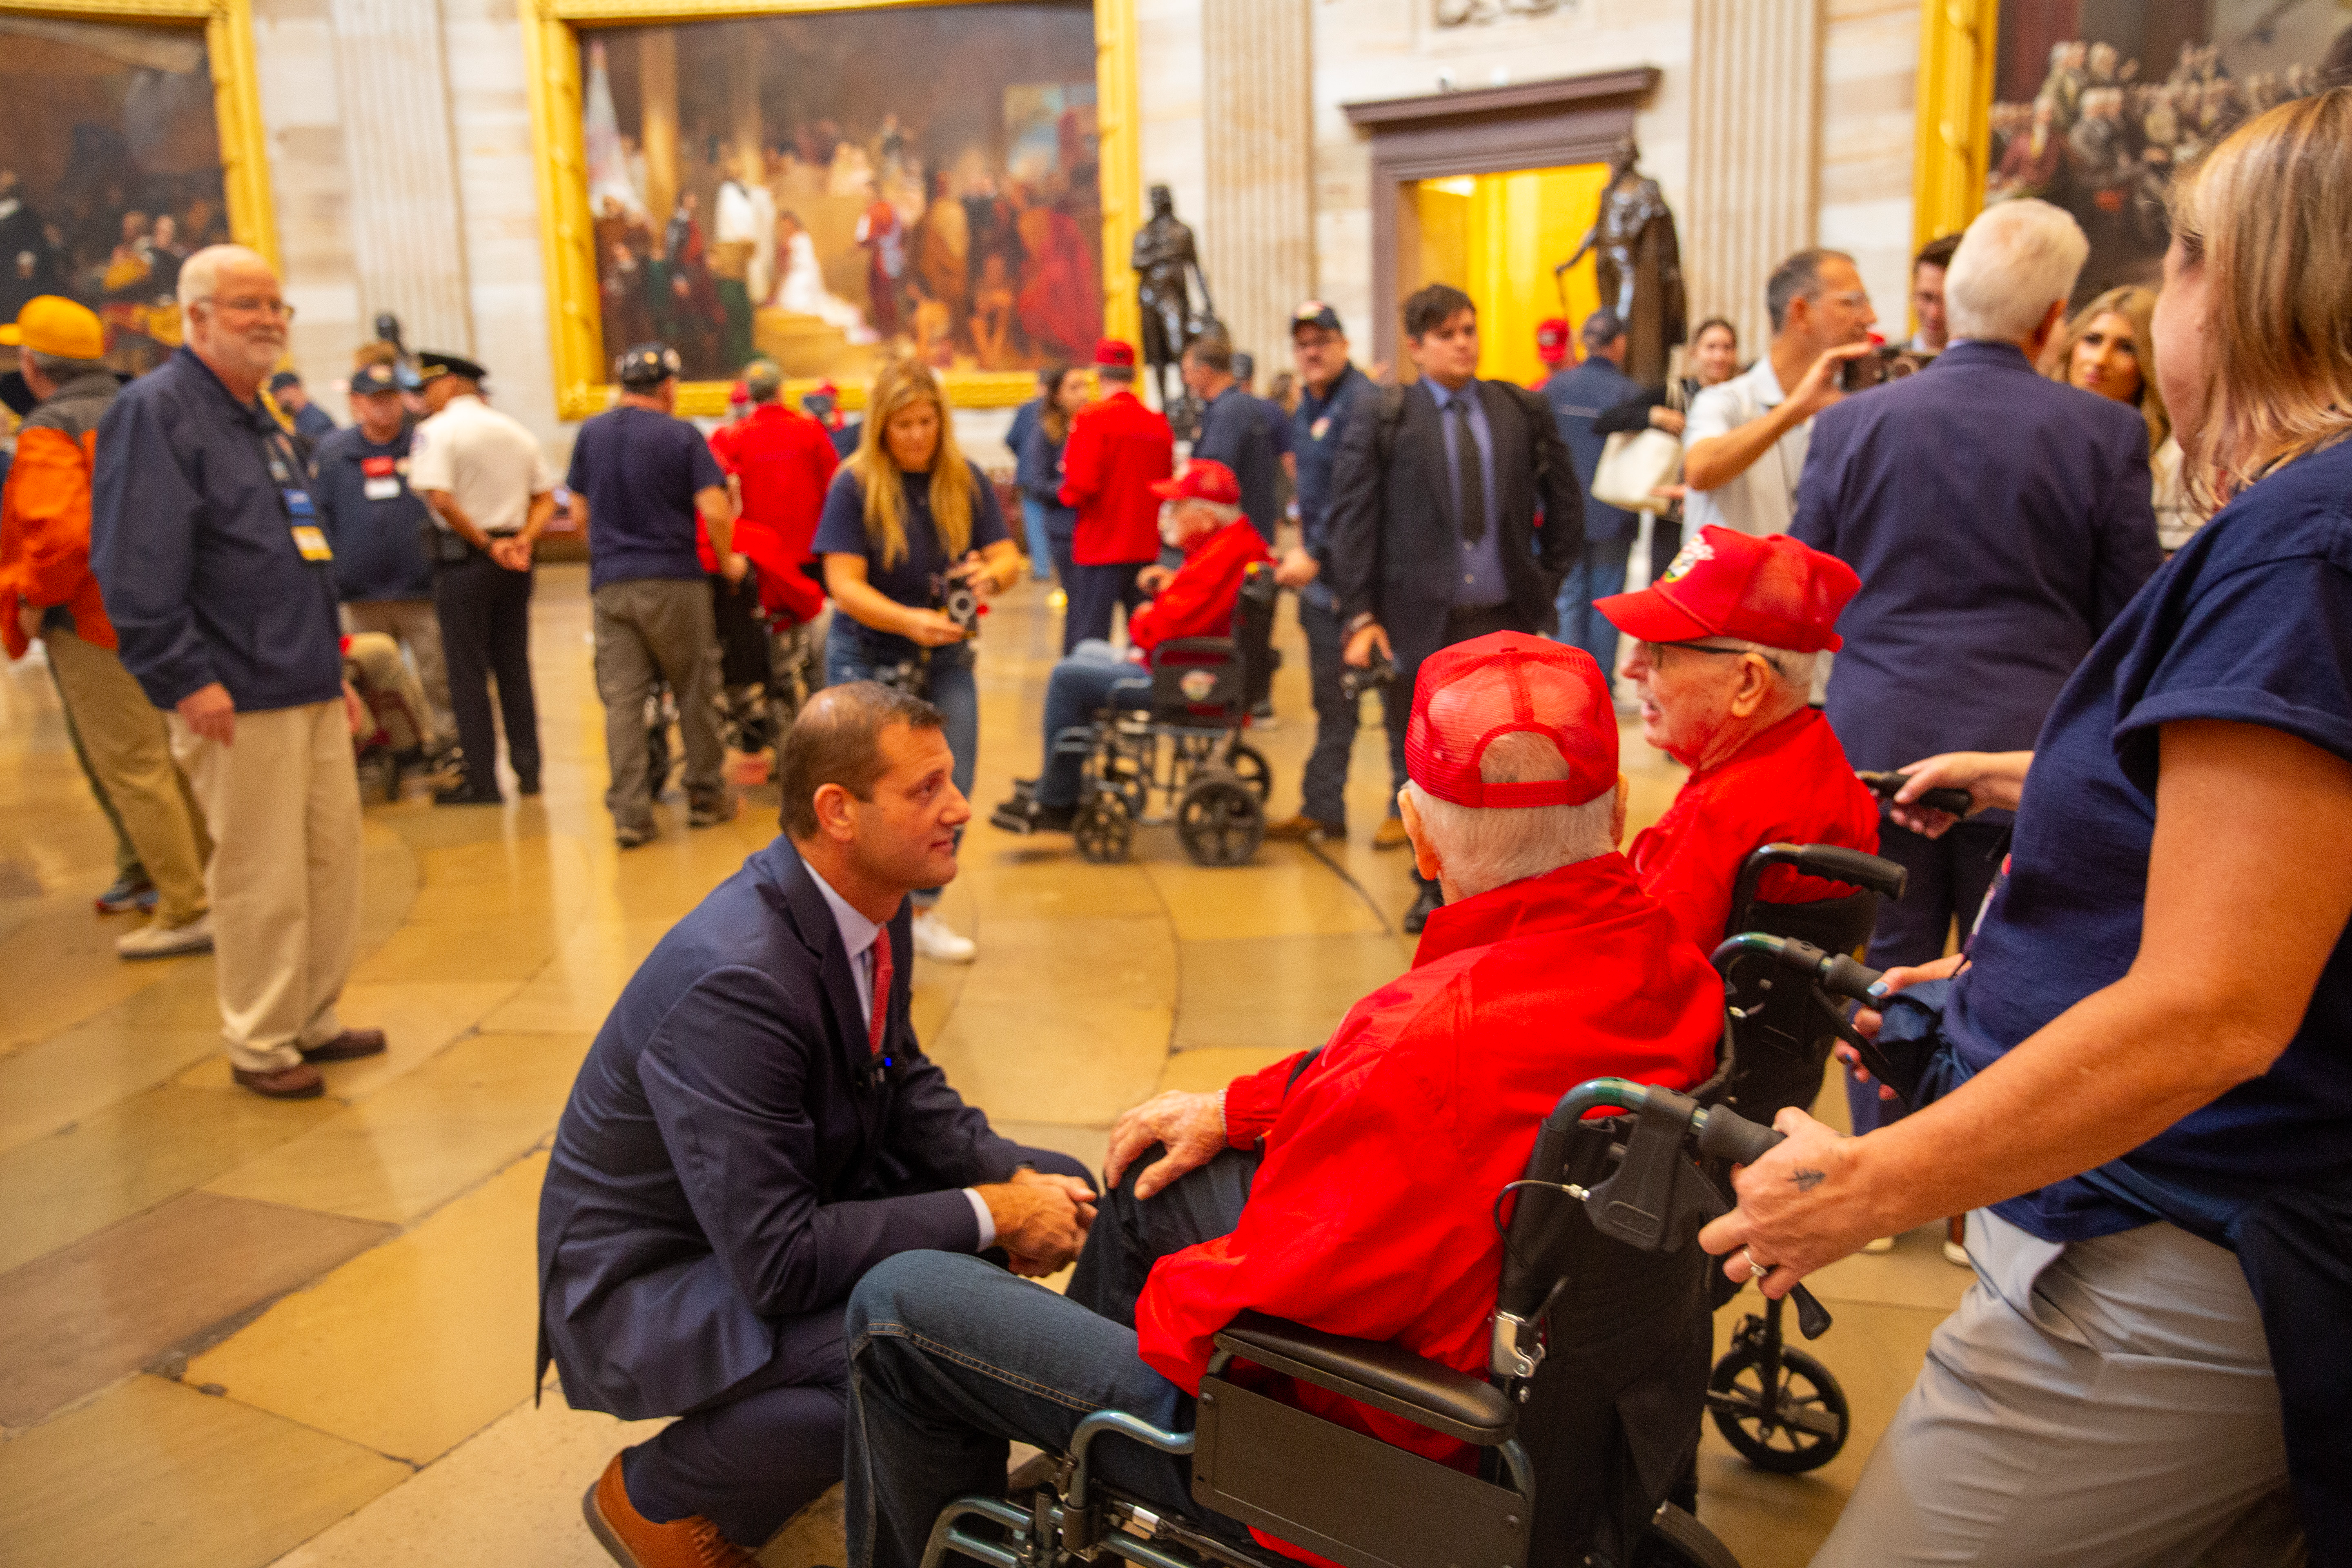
left=89, top=348, right=343, bottom=712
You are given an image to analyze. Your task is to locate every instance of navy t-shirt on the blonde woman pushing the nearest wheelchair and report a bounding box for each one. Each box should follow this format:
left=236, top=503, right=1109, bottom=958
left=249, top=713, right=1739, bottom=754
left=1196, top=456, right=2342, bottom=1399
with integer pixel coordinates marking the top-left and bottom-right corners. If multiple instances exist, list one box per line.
left=1943, top=442, right=2352, bottom=1241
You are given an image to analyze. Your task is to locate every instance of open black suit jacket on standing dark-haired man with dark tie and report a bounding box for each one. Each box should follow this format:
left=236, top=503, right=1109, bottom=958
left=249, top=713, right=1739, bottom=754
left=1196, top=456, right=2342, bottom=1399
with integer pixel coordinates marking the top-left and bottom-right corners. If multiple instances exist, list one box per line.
left=1324, top=381, right=1585, bottom=677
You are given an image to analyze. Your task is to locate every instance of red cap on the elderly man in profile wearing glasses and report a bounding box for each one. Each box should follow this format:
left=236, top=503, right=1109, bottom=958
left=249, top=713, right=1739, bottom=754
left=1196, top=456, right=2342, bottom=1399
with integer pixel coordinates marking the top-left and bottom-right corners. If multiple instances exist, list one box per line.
left=1592, top=524, right=1863, bottom=653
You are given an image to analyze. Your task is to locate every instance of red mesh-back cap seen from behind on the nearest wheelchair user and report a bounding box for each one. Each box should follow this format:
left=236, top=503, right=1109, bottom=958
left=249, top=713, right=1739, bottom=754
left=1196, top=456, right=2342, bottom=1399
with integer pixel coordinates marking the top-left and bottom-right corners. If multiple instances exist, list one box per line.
left=1404, top=633, right=1616, bottom=806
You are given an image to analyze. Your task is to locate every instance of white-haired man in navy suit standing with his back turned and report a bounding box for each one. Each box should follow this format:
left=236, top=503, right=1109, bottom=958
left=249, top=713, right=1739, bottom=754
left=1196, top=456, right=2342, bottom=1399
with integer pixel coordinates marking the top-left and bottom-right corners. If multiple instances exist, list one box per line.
left=1790, top=200, right=2164, bottom=1114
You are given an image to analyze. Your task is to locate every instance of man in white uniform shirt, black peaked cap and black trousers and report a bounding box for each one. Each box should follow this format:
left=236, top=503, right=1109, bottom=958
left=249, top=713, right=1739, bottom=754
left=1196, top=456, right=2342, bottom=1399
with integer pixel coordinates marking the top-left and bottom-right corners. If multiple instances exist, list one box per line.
left=409, top=350, right=555, bottom=806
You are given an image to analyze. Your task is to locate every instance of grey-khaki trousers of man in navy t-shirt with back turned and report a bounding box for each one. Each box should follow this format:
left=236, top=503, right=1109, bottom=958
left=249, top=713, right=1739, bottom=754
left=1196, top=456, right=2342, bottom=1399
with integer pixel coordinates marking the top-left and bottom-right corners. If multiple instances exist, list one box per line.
left=593, top=578, right=727, bottom=828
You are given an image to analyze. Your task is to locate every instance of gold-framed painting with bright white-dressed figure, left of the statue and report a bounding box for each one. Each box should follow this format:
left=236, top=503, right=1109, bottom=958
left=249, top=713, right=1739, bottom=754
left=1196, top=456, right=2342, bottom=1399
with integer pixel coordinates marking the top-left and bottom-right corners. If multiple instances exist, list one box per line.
left=522, top=0, right=1138, bottom=419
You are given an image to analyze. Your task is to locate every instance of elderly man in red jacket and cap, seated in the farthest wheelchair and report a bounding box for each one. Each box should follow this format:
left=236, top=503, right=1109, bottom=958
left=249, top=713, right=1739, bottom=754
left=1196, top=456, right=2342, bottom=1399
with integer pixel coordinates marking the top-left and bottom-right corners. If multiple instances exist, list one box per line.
left=988, top=459, right=1272, bottom=832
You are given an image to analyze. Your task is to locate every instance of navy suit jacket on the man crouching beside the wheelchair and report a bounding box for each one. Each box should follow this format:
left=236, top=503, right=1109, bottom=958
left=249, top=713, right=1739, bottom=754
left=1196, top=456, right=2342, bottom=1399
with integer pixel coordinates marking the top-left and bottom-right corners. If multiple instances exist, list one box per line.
left=539, top=837, right=1063, bottom=1420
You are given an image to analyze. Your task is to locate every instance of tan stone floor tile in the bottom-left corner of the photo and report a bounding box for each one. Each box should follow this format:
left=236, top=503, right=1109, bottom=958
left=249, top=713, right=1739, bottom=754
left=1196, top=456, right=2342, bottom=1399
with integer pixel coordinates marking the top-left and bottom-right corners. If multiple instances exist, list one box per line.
left=0, top=1375, right=409, bottom=1568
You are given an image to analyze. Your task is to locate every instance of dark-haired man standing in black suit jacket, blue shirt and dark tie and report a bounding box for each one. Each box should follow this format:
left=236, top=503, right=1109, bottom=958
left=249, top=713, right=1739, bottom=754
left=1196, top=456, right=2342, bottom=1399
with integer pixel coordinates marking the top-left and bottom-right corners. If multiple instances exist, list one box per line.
left=1329, top=282, right=1585, bottom=933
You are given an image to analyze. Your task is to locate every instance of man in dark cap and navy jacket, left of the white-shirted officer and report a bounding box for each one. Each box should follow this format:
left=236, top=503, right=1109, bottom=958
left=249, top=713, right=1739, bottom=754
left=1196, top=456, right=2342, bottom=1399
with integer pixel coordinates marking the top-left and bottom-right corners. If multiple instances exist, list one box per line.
left=310, top=364, right=456, bottom=757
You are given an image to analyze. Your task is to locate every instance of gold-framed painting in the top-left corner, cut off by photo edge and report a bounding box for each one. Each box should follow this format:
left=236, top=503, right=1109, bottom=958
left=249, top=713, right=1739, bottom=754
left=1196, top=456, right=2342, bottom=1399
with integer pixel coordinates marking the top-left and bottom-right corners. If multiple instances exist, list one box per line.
left=0, top=0, right=278, bottom=374
